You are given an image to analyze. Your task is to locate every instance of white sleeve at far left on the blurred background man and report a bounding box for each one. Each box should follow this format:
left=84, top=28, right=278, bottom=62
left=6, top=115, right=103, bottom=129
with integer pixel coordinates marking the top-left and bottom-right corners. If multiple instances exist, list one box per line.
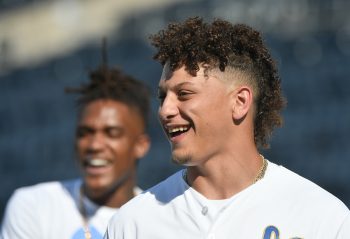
left=0, top=189, right=40, bottom=239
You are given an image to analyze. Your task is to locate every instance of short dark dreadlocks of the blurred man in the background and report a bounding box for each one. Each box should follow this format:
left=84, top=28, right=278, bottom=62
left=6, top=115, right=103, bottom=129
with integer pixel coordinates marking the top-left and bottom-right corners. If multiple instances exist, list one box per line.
left=66, top=44, right=150, bottom=127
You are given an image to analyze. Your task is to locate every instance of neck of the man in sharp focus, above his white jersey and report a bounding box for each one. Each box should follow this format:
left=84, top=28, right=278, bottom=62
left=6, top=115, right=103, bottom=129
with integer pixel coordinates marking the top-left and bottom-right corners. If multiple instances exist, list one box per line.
left=187, top=151, right=264, bottom=199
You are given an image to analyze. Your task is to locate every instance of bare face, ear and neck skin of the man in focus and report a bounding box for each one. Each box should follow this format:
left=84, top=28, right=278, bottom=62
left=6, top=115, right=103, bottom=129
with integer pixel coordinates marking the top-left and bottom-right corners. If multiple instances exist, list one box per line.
left=158, top=65, right=262, bottom=199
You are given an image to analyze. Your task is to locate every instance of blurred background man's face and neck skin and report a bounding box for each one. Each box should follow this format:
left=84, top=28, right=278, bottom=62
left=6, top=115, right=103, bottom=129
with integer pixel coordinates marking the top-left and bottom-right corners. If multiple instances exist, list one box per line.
left=76, top=100, right=150, bottom=207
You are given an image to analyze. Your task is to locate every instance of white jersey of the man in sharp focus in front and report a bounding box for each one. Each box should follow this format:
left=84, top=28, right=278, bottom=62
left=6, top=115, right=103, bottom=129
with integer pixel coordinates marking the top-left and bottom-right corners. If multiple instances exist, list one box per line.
left=105, top=162, right=350, bottom=239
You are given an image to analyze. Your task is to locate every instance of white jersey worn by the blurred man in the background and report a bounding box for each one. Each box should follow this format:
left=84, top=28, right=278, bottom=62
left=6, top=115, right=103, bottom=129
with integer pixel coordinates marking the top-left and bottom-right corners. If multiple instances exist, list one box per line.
left=0, top=179, right=140, bottom=239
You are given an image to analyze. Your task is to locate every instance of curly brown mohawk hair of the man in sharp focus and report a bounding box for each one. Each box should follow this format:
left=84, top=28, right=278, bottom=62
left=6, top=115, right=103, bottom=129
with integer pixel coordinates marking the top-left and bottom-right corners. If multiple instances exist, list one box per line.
left=150, top=17, right=286, bottom=148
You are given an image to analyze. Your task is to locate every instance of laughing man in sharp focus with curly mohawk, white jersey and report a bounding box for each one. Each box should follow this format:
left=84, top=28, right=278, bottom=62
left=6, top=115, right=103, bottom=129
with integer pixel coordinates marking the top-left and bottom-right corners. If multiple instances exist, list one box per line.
left=106, top=18, right=350, bottom=239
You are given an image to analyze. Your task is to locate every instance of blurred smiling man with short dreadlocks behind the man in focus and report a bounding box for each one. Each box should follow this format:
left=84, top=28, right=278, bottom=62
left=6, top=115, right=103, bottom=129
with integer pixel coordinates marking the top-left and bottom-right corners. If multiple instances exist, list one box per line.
left=1, top=60, right=150, bottom=239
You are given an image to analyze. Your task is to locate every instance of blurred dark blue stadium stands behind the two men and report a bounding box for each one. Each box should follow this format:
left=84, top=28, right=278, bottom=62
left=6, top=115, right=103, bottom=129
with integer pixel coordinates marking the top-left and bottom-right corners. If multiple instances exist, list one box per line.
left=0, top=0, right=350, bottom=221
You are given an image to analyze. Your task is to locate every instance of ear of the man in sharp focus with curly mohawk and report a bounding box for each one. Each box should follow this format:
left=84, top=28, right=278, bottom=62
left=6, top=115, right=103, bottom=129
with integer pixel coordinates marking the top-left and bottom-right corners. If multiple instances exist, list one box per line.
left=232, top=86, right=253, bottom=122
